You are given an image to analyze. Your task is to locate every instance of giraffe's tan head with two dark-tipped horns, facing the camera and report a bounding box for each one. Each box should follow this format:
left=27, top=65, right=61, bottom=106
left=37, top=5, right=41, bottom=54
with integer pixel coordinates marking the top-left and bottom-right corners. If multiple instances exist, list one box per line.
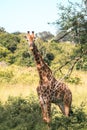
left=26, top=31, right=35, bottom=49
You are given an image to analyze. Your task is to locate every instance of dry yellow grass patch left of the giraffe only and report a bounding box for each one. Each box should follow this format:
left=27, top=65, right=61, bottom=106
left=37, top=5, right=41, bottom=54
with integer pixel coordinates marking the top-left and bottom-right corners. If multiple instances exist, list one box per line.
left=0, top=66, right=38, bottom=102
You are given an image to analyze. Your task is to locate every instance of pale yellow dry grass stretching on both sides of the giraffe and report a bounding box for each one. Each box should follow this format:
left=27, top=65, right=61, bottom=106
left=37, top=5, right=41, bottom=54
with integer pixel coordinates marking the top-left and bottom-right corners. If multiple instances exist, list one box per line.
left=0, top=66, right=87, bottom=110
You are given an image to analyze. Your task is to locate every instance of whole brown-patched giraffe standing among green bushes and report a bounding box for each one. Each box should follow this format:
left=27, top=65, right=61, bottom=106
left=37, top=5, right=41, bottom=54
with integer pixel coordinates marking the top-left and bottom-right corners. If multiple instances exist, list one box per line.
left=26, top=31, right=72, bottom=124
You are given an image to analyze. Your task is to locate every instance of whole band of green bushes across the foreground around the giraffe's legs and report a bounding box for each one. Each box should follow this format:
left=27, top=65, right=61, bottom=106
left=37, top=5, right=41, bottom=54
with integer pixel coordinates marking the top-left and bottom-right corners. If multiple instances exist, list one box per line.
left=0, top=95, right=87, bottom=130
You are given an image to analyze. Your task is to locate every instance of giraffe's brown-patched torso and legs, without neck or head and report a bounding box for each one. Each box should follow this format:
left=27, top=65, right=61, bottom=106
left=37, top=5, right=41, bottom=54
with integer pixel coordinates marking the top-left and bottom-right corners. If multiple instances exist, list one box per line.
left=37, top=78, right=72, bottom=123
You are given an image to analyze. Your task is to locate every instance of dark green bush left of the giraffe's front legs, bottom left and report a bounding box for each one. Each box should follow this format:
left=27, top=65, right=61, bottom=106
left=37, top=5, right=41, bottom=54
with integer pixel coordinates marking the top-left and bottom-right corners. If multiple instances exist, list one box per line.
left=0, top=97, right=42, bottom=130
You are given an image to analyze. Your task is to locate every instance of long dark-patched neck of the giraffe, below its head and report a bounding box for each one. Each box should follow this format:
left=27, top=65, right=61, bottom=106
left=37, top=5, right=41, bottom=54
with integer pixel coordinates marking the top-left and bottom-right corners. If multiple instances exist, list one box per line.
left=32, top=43, right=52, bottom=84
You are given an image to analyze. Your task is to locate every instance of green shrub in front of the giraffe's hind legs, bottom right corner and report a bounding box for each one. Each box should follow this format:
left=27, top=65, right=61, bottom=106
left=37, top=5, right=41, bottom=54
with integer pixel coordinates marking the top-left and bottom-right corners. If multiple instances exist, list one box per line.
left=51, top=104, right=87, bottom=130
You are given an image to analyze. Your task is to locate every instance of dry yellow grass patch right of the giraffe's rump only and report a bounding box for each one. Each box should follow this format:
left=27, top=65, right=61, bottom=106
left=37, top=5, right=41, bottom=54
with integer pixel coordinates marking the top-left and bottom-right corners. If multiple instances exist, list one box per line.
left=69, top=71, right=87, bottom=111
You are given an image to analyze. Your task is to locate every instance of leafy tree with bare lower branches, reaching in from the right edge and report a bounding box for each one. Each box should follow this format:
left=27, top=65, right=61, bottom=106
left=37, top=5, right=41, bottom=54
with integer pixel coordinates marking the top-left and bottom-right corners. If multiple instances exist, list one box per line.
left=53, top=0, right=87, bottom=78
